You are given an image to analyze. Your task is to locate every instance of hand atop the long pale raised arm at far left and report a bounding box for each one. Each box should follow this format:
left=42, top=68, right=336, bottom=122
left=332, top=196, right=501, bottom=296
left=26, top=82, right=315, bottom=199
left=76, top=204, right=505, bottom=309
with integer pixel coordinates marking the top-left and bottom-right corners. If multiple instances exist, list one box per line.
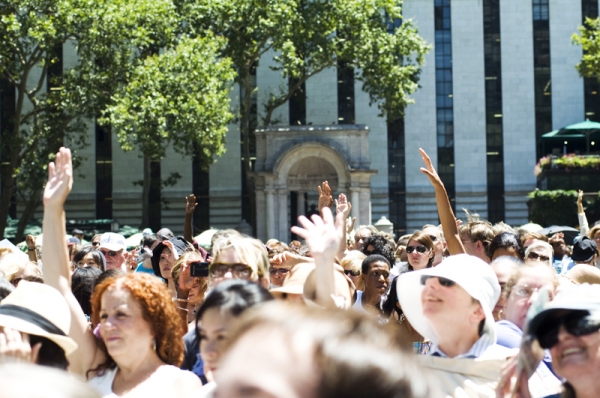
left=43, top=148, right=73, bottom=207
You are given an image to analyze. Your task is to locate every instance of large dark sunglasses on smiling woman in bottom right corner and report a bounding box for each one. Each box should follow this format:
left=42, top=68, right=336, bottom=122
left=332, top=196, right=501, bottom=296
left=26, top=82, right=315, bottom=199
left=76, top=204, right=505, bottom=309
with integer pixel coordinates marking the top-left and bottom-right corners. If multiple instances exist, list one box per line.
left=538, top=311, right=600, bottom=348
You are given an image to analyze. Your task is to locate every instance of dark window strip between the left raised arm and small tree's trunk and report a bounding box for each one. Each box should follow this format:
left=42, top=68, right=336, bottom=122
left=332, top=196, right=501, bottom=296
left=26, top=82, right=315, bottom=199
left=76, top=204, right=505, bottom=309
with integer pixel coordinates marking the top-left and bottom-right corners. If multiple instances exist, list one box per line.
left=96, top=123, right=113, bottom=219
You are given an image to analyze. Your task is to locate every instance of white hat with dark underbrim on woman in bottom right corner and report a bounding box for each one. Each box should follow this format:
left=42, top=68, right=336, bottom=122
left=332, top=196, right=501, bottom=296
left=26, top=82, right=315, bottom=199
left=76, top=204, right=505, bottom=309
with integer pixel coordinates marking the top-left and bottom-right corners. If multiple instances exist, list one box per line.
left=527, top=282, right=600, bottom=336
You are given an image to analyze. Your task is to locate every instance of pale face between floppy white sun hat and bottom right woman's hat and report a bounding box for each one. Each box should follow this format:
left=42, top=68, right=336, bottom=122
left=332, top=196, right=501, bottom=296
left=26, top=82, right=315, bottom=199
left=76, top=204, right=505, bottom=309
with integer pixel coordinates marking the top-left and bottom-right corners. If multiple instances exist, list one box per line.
left=504, top=266, right=555, bottom=330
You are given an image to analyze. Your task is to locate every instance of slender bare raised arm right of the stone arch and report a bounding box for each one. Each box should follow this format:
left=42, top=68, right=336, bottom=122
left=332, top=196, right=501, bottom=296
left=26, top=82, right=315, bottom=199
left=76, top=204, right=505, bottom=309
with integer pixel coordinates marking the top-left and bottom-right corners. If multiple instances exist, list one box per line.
left=419, top=148, right=466, bottom=255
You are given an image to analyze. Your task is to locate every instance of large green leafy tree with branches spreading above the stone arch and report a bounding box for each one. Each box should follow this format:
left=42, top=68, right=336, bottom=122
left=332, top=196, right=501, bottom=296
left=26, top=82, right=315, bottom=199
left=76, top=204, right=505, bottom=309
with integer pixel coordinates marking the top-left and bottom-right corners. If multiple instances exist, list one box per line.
left=174, top=0, right=429, bottom=230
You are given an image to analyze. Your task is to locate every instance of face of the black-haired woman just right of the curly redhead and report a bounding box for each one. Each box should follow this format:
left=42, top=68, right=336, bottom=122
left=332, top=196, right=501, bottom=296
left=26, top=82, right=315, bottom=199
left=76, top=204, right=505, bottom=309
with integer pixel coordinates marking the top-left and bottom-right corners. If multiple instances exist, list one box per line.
left=197, top=307, right=235, bottom=372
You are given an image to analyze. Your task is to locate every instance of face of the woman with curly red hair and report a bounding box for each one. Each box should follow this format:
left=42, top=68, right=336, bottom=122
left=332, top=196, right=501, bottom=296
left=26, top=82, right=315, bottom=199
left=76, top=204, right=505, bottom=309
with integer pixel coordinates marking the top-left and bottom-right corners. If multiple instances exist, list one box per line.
left=100, top=287, right=154, bottom=364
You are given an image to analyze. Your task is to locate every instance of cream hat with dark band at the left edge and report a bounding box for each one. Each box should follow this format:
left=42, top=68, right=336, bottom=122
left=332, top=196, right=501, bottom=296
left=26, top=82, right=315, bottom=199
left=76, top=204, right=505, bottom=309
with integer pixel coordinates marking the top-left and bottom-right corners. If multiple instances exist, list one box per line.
left=0, top=281, right=77, bottom=355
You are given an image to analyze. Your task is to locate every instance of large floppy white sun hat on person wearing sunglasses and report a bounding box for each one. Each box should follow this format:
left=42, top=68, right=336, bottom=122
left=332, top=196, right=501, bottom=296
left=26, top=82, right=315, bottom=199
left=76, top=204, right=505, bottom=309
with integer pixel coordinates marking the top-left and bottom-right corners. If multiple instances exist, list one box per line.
left=396, top=254, right=500, bottom=344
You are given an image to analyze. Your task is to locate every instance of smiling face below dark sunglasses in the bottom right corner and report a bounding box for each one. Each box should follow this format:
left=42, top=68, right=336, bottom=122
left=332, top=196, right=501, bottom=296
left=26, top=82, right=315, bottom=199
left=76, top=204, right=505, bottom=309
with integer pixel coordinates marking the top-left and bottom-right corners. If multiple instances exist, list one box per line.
left=550, top=326, right=600, bottom=384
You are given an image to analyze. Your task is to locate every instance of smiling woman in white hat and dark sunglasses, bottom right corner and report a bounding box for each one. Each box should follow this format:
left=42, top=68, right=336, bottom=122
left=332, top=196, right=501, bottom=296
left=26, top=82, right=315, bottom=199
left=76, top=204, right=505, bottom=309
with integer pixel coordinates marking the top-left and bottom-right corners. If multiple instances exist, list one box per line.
left=497, top=284, right=600, bottom=398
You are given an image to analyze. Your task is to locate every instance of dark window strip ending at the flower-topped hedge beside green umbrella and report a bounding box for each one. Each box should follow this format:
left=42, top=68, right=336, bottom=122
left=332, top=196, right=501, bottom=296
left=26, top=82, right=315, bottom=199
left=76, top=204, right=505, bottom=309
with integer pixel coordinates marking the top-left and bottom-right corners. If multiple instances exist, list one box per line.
left=532, top=0, right=552, bottom=159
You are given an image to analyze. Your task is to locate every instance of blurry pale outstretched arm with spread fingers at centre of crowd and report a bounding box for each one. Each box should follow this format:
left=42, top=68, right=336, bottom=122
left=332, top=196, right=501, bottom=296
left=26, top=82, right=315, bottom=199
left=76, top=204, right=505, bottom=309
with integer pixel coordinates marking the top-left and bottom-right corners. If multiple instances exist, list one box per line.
left=292, top=207, right=346, bottom=308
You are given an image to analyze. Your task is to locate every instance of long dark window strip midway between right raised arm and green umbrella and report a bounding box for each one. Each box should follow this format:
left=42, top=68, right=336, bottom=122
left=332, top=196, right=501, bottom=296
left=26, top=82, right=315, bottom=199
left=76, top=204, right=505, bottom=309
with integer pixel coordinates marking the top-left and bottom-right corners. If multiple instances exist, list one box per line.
left=483, top=0, right=504, bottom=223
